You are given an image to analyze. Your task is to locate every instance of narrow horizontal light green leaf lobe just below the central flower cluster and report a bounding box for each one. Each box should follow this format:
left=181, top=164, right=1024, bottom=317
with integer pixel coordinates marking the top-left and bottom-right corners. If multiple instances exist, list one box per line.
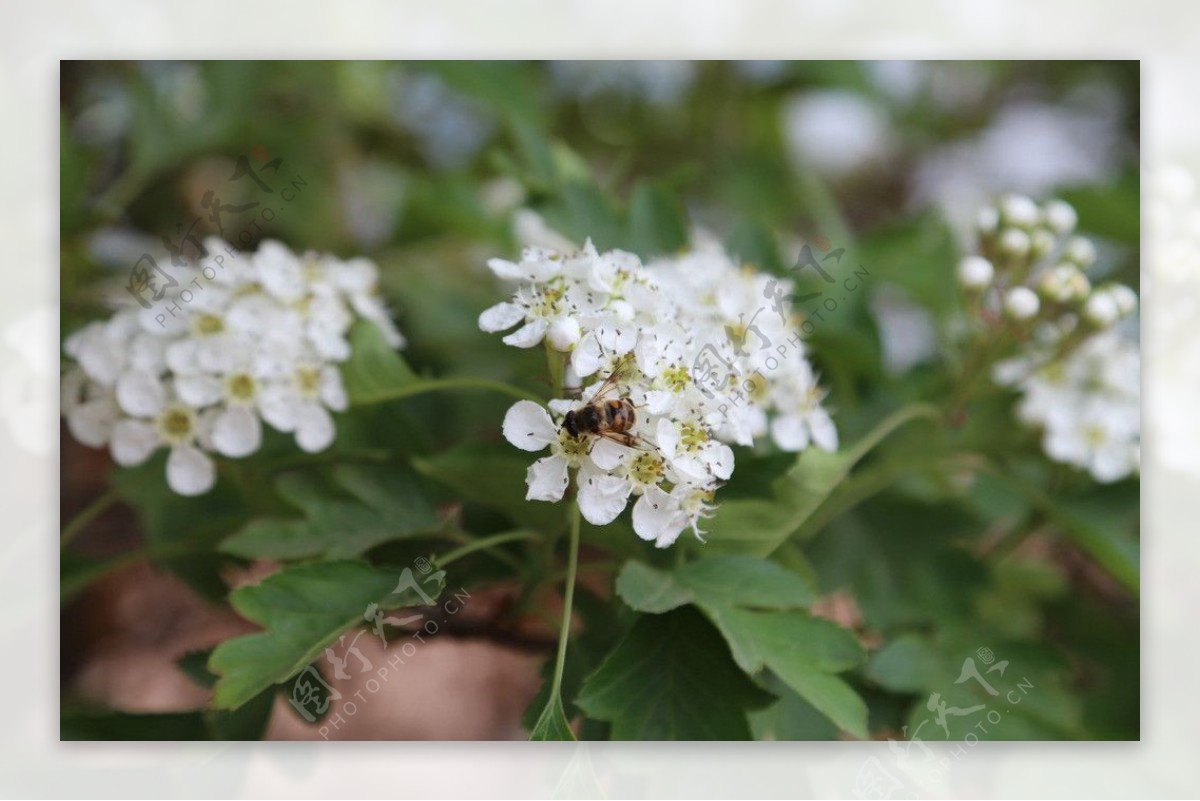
left=617, top=556, right=814, bottom=614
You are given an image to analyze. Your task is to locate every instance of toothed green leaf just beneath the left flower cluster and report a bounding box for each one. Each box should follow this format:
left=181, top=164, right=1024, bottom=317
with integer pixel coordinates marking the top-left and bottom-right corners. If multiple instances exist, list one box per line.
left=221, top=464, right=439, bottom=559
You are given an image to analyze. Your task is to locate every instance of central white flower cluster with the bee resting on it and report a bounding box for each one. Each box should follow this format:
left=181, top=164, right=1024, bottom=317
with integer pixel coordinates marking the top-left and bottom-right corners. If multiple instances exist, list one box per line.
left=479, top=241, right=838, bottom=548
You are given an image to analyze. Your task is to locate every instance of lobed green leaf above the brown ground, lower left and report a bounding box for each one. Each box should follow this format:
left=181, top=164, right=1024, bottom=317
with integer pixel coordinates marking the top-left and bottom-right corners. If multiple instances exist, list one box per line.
left=209, top=561, right=440, bottom=709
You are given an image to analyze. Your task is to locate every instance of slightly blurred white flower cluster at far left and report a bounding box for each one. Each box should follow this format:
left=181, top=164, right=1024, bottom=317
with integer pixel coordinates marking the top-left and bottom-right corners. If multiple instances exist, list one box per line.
left=62, top=239, right=403, bottom=495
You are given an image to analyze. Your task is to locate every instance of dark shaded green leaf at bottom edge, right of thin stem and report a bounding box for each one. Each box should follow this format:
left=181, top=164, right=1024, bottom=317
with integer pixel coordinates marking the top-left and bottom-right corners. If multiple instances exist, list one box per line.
left=576, top=608, right=774, bottom=740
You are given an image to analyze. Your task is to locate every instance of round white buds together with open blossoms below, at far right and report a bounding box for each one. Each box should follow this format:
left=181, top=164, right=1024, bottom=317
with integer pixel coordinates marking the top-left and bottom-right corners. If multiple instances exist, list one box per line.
left=959, top=195, right=1141, bottom=482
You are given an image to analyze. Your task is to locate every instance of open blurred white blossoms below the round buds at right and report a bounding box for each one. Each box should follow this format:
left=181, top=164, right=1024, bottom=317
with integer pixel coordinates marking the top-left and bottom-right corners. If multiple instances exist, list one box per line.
left=994, top=329, right=1141, bottom=483
